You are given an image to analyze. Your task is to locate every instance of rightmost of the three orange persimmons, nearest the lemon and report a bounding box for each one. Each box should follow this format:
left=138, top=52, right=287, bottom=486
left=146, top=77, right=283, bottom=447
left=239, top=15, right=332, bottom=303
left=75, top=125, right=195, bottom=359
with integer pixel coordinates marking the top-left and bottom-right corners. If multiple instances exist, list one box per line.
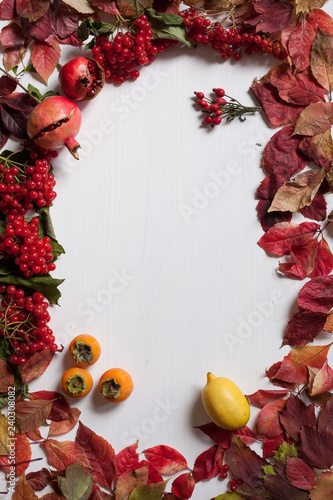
left=98, top=368, right=133, bottom=403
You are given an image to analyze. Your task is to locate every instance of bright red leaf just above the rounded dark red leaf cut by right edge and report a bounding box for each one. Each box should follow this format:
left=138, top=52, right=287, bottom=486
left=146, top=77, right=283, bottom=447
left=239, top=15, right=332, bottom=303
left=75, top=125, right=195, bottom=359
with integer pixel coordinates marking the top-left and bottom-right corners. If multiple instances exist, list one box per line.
left=279, top=239, right=318, bottom=280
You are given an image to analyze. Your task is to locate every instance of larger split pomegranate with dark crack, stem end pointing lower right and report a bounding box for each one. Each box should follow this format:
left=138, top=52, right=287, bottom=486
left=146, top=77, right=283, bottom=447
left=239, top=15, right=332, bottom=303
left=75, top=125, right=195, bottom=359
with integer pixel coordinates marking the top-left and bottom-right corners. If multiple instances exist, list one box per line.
left=27, top=96, right=82, bottom=160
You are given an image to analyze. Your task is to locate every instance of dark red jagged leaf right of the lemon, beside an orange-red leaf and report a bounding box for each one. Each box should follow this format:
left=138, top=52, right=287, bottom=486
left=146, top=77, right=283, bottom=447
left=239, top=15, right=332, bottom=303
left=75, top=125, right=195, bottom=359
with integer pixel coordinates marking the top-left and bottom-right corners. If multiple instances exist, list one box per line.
left=280, top=394, right=316, bottom=441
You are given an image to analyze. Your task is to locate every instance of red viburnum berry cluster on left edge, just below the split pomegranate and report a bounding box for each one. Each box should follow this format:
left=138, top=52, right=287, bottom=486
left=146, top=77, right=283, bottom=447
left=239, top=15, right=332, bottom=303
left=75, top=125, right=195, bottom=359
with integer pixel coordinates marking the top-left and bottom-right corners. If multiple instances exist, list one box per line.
left=0, top=151, right=58, bottom=216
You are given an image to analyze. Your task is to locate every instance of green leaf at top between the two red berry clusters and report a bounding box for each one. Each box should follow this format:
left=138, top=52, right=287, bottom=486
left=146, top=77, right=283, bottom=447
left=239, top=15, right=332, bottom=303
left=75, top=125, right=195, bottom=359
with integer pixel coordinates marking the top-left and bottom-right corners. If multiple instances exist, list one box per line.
left=144, top=8, right=192, bottom=47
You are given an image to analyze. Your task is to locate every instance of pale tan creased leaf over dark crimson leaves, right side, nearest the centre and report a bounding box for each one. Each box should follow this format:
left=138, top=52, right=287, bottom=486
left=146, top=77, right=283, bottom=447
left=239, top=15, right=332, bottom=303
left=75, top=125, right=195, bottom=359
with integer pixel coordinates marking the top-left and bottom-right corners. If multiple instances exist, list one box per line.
left=268, top=169, right=325, bottom=212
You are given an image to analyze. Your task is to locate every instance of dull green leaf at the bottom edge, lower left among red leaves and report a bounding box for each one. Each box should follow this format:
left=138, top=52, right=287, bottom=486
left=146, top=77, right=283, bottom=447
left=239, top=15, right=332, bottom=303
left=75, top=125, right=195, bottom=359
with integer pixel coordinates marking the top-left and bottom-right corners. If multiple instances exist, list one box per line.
left=58, top=464, right=93, bottom=500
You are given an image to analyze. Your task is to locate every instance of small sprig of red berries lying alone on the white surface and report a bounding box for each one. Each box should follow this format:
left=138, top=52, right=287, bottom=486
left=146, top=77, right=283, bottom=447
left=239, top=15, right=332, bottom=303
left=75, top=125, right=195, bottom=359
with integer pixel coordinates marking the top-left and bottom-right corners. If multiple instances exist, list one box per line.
left=194, top=88, right=261, bottom=127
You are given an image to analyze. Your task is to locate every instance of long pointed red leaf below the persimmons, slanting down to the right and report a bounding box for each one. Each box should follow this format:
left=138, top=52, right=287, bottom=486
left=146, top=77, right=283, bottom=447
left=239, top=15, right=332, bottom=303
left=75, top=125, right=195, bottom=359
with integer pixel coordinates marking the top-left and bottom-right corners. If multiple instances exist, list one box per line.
left=75, top=422, right=115, bottom=490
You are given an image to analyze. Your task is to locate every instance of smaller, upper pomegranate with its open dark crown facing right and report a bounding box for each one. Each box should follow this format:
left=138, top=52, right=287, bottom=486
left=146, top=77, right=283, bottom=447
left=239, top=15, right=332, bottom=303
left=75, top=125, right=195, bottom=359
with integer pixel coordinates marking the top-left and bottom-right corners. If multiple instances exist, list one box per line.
left=59, top=57, right=105, bottom=101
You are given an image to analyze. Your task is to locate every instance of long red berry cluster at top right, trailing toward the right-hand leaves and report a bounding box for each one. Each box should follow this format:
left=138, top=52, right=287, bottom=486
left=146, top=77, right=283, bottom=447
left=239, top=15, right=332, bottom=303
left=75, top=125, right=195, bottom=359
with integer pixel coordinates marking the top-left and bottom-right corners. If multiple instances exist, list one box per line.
left=179, top=8, right=287, bottom=61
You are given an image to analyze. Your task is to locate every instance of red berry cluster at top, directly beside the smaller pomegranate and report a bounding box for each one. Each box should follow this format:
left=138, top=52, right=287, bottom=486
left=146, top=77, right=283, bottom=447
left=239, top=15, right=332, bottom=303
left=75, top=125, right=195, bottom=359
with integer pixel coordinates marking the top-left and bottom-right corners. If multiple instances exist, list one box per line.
left=92, top=14, right=177, bottom=84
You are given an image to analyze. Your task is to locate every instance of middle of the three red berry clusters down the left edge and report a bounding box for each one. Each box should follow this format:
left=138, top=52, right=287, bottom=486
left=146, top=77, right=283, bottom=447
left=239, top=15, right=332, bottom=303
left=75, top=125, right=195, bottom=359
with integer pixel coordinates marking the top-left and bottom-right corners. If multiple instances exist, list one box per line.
left=0, top=215, right=55, bottom=278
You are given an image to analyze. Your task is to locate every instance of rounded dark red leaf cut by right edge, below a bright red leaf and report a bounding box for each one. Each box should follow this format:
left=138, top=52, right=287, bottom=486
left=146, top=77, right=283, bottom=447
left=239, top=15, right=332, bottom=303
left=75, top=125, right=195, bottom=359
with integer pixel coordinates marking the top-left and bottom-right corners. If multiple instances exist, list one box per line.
left=297, top=275, right=333, bottom=314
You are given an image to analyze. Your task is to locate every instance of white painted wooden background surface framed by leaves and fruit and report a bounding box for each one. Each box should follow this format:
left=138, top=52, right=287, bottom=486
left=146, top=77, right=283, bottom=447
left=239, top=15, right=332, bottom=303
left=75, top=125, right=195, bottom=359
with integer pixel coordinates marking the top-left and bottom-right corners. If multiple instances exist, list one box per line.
left=2, top=2, right=333, bottom=500
